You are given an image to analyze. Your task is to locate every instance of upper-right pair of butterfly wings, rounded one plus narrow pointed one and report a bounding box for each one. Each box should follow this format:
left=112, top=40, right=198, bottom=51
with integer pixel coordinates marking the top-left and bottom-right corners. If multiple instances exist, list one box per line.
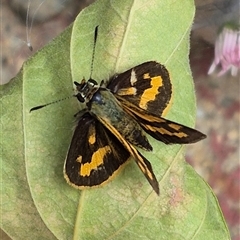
left=107, top=61, right=206, bottom=144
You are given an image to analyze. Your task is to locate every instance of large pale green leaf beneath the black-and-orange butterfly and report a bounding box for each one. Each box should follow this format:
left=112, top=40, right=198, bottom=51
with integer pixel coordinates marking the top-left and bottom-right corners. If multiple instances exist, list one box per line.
left=1, top=0, right=230, bottom=240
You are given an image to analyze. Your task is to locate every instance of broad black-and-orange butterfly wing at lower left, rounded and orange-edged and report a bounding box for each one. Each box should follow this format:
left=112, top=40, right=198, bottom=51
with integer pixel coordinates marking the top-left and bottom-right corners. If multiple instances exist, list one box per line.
left=64, top=113, right=130, bottom=189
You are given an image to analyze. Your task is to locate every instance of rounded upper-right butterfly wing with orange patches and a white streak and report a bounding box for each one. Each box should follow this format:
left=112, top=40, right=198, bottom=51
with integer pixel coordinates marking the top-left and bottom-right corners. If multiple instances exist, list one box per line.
left=107, top=61, right=172, bottom=116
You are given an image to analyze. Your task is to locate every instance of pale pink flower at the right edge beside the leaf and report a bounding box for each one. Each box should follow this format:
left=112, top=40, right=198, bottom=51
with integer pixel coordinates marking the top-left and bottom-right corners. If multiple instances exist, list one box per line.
left=208, top=25, right=240, bottom=76
